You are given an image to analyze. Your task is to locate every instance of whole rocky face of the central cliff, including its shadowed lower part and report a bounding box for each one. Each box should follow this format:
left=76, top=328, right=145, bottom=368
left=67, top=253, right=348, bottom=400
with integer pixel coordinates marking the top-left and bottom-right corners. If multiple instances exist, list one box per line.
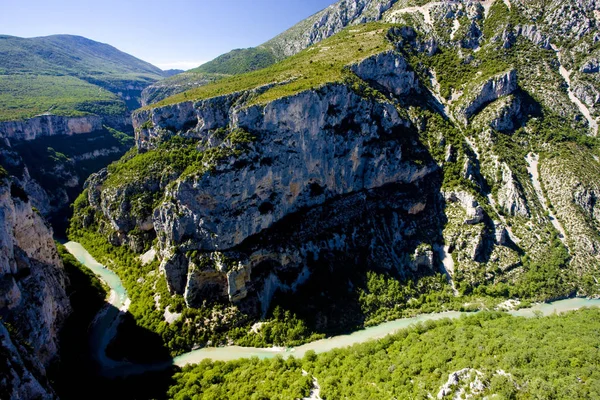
left=81, top=74, right=446, bottom=313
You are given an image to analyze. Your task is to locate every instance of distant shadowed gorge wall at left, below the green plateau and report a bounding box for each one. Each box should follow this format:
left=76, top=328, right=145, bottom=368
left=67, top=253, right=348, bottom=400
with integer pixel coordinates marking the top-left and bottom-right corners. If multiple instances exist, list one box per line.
left=0, top=115, right=133, bottom=231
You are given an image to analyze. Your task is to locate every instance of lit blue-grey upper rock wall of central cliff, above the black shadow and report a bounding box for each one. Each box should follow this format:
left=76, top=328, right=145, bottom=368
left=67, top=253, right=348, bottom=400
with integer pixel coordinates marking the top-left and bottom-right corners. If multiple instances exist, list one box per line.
left=149, top=85, right=422, bottom=251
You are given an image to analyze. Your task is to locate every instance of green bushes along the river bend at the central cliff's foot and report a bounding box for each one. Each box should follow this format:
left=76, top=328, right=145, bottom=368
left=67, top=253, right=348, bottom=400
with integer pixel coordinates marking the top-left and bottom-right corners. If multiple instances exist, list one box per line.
left=69, top=212, right=323, bottom=361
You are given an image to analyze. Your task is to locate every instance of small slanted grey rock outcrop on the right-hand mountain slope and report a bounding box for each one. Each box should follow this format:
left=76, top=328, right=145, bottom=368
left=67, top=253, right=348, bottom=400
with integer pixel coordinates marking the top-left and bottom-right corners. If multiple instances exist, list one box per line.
left=456, top=69, right=518, bottom=124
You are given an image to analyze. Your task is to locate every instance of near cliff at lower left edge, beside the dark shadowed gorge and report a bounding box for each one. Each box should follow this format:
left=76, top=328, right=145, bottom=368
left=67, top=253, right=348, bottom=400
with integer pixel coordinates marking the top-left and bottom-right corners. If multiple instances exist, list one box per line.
left=0, top=179, right=70, bottom=398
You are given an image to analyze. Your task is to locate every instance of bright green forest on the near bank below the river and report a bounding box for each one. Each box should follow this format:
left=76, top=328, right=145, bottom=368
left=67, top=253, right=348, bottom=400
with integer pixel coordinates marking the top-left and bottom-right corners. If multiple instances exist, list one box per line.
left=168, top=309, right=600, bottom=400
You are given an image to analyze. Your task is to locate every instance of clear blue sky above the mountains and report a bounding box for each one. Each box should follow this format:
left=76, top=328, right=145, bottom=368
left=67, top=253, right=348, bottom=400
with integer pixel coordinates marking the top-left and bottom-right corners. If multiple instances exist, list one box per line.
left=0, top=0, right=335, bottom=69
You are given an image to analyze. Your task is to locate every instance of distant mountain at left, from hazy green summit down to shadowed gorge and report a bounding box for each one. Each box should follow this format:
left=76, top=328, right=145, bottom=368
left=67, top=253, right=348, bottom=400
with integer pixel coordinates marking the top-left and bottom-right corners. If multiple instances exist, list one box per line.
left=0, top=35, right=168, bottom=232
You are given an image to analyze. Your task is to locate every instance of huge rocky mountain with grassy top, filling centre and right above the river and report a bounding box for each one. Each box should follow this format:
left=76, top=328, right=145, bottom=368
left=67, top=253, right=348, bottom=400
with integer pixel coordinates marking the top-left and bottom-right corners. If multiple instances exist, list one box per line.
left=70, top=0, right=600, bottom=364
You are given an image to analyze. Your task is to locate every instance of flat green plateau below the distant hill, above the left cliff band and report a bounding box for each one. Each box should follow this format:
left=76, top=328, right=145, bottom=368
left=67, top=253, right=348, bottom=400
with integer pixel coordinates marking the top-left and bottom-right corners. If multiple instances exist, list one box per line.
left=0, top=75, right=126, bottom=121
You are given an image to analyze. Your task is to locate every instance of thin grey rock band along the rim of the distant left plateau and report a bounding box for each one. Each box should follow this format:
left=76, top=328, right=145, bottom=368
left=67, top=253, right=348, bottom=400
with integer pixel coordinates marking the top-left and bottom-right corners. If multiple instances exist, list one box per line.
left=0, top=115, right=127, bottom=140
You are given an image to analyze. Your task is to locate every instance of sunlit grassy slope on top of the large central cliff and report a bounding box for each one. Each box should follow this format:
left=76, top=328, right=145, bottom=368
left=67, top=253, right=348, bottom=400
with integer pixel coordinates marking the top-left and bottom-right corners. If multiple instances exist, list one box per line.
left=147, top=23, right=392, bottom=108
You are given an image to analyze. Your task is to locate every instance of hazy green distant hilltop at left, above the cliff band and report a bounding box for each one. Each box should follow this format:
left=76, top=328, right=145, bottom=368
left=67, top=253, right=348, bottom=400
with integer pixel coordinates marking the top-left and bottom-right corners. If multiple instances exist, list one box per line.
left=0, top=35, right=170, bottom=114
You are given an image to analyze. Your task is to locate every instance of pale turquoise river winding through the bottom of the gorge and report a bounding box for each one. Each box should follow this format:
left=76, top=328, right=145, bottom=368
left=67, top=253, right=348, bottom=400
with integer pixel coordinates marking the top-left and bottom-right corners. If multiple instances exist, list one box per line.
left=65, top=242, right=600, bottom=376
